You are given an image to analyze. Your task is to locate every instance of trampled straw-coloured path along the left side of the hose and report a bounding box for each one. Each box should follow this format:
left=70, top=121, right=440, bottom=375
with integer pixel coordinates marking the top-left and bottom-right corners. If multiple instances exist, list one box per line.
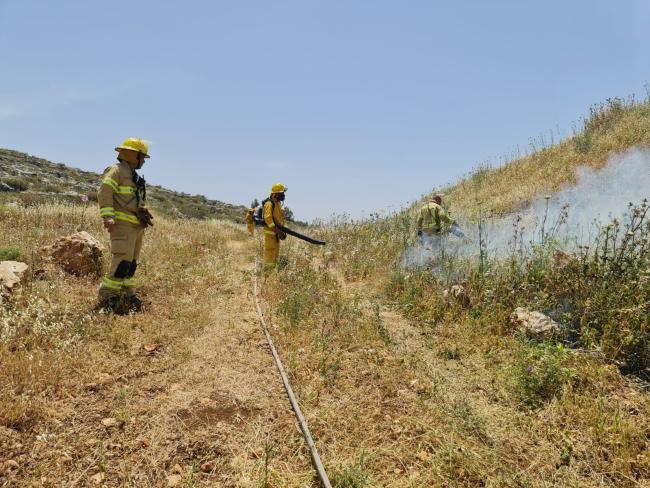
left=8, top=241, right=312, bottom=487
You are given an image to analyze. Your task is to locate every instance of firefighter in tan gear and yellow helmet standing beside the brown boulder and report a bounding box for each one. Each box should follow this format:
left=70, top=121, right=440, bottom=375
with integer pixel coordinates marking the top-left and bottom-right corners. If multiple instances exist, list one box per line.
left=97, top=138, right=153, bottom=311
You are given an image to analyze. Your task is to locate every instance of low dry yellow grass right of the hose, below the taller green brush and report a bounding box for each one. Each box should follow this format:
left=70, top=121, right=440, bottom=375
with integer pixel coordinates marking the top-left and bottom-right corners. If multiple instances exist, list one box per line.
left=266, top=236, right=650, bottom=487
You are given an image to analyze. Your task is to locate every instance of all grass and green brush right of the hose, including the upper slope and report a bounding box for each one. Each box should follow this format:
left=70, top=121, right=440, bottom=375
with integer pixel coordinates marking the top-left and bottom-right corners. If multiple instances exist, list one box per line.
left=268, top=100, right=650, bottom=487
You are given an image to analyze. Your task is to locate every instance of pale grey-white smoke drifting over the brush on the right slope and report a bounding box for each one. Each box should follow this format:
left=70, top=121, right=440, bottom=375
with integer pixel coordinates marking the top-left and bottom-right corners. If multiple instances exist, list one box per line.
left=402, top=147, right=650, bottom=268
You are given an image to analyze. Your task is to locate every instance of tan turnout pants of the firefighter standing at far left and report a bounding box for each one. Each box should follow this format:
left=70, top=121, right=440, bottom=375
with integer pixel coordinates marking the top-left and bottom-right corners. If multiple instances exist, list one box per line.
left=99, top=220, right=144, bottom=300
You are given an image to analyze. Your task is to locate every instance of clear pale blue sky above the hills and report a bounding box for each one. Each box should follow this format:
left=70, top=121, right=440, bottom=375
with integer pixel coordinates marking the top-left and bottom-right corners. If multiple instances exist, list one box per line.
left=0, top=0, right=650, bottom=219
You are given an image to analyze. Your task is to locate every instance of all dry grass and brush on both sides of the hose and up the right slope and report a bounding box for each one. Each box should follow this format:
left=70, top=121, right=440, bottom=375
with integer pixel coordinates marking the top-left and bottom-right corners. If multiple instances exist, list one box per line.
left=0, top=100, right=650, bottom=488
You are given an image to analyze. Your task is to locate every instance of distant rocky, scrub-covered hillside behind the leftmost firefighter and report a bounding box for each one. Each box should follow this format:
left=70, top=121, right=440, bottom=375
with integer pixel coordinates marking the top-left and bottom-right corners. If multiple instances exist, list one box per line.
left=0, top=149, right=247, bottom=222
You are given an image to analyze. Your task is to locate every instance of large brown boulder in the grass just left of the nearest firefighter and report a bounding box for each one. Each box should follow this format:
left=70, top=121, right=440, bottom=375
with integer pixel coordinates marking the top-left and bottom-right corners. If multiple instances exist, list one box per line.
left=41, top=231, right=104, bottom=276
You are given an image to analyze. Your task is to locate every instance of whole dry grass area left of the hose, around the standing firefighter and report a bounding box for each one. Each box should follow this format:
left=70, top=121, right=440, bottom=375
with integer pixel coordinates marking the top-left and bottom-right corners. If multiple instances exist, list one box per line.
left=0, top=205, right=311, bottom=486
